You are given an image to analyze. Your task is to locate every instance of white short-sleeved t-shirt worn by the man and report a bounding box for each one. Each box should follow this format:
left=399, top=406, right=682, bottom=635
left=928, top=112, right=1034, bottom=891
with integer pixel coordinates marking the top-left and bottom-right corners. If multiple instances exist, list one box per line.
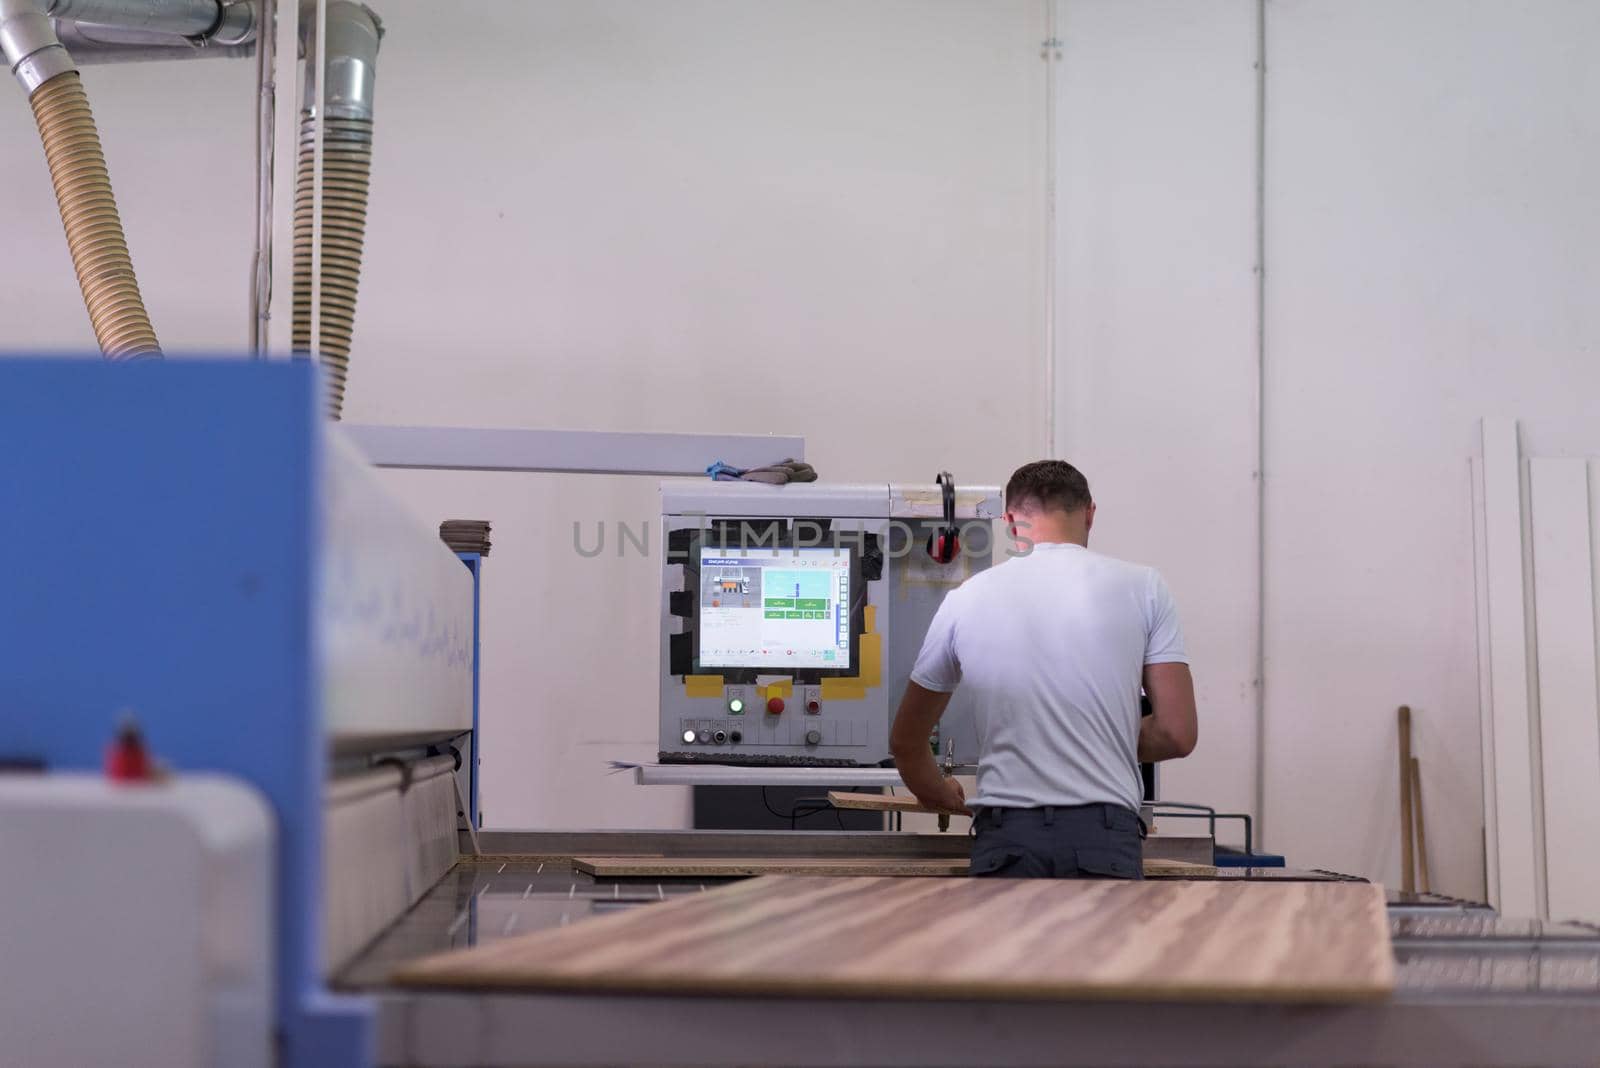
left=910, top=542, right=1189, bottom=811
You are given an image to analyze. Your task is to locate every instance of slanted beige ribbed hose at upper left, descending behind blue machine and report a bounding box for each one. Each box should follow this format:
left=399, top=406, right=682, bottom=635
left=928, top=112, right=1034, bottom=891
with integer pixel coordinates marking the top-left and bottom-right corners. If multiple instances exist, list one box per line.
left=29, top=70, right=162, bottom=360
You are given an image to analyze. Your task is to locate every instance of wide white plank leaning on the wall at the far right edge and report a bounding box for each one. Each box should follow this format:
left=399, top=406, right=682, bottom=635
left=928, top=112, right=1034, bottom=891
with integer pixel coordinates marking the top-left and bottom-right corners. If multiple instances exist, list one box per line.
left=1528, top=459, right=1600, bottom=919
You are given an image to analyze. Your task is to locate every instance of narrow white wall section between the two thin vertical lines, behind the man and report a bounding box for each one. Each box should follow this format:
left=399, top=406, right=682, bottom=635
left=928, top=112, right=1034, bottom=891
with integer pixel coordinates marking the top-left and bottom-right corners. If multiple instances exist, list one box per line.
left=1056, top=0, right=1256, bottom=838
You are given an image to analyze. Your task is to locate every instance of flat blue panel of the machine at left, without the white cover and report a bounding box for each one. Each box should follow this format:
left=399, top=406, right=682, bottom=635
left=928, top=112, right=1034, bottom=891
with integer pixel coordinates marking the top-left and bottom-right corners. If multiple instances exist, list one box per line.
left=0, top=358, right=361, bottom=1065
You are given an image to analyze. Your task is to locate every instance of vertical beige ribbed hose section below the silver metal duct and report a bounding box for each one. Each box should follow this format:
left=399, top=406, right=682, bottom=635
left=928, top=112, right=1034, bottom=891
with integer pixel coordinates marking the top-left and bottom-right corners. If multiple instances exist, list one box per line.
left=293, top=109, right=373, bottom=419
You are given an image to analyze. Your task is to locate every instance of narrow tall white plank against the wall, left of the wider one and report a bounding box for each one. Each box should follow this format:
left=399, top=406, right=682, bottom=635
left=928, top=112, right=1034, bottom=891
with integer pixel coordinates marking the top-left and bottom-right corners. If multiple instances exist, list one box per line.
left=1482, top=419, right=1544, bottom=918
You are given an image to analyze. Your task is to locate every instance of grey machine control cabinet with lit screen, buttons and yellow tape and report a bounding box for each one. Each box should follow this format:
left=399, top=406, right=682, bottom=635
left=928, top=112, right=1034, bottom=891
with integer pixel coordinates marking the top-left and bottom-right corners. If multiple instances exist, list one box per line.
left=659, top=480, right=1002, bottom=766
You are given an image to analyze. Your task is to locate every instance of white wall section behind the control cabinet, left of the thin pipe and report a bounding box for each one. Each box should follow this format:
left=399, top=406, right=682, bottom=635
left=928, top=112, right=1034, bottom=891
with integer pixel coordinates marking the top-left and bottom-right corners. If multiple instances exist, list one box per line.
left=346, top=0, right=1046, bottom=827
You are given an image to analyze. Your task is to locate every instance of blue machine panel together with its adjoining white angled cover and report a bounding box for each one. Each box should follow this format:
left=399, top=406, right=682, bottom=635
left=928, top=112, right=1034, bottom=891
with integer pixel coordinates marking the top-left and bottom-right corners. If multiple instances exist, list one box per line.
left=0, top=358, right=482, bottom=1068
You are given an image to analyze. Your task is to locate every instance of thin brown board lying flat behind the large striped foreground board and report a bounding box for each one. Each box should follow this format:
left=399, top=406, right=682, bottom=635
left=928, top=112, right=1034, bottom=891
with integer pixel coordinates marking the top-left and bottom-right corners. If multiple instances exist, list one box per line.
left=573, top=857, right=1216, bottom=879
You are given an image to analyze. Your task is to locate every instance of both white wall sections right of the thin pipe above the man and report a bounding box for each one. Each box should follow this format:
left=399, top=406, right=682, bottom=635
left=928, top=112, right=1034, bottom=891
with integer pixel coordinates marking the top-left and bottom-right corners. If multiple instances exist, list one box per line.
left=1058, top=0, right=1600, bottom=895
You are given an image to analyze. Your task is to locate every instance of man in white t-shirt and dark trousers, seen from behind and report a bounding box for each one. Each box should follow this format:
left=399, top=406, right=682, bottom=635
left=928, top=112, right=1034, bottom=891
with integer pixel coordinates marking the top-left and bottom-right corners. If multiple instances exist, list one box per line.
left=890, top=460, right=1198, bottom=879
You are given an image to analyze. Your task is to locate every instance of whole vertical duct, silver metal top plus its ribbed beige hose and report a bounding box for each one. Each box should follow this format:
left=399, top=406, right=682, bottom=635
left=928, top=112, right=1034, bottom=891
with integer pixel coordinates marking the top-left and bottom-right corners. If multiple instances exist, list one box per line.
left=293, top=0, right=382, bottom=419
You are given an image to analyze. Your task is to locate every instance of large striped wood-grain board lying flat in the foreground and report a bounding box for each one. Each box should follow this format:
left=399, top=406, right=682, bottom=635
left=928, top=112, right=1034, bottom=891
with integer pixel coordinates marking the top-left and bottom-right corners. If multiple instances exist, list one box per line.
left=394, top=876, right=1394, bottom=1004
